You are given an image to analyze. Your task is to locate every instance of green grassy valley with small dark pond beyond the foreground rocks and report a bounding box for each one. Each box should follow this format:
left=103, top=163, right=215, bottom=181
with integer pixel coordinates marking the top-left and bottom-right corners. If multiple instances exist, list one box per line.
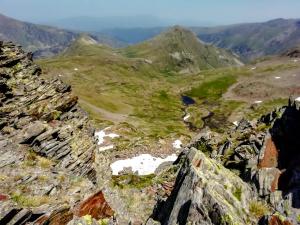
left=38, top=29, right=300, bottom=162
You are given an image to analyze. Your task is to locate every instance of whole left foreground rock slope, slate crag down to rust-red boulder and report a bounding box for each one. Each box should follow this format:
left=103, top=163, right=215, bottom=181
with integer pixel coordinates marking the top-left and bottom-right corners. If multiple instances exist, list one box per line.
left=0, top=42, right=114, bottom=225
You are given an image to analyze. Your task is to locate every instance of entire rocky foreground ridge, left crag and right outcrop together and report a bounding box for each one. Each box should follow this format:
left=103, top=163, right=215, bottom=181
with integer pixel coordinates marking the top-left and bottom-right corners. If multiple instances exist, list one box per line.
left=0, top=42, right=300, bottom=225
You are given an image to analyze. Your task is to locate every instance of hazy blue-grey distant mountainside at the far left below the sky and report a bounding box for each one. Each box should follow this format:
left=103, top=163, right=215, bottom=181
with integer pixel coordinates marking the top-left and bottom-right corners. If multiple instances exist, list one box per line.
left=0, top=14, right=78, bottom=57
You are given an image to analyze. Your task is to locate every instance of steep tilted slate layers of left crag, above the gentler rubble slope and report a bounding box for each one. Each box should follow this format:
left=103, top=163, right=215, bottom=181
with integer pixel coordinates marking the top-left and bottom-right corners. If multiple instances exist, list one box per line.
left=0, top=40, right=96, bottom=181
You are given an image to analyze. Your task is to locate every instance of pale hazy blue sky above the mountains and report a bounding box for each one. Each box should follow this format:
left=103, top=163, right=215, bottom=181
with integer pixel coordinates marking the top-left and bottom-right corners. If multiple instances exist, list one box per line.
left=0, top=0, right=300, bottom=24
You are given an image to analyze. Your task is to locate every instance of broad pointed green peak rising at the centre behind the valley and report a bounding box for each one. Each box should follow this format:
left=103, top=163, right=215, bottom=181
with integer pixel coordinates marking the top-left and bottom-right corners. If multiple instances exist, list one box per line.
left=122, top=26, right=242, bottom=73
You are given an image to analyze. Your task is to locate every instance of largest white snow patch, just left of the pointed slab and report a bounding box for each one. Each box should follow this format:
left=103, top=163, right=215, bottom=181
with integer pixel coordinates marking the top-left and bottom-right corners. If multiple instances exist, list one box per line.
left=110, top=154, right=177, bottom=176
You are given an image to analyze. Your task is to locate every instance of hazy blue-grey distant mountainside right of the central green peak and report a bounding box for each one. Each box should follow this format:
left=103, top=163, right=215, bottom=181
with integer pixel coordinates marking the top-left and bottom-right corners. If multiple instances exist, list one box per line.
left=192, top=19, right=300, bottom=60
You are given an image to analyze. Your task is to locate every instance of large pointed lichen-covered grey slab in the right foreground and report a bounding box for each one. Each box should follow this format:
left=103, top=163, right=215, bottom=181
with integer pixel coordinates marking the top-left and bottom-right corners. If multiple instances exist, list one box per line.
left=154, top=148, right=255, bottom=225
